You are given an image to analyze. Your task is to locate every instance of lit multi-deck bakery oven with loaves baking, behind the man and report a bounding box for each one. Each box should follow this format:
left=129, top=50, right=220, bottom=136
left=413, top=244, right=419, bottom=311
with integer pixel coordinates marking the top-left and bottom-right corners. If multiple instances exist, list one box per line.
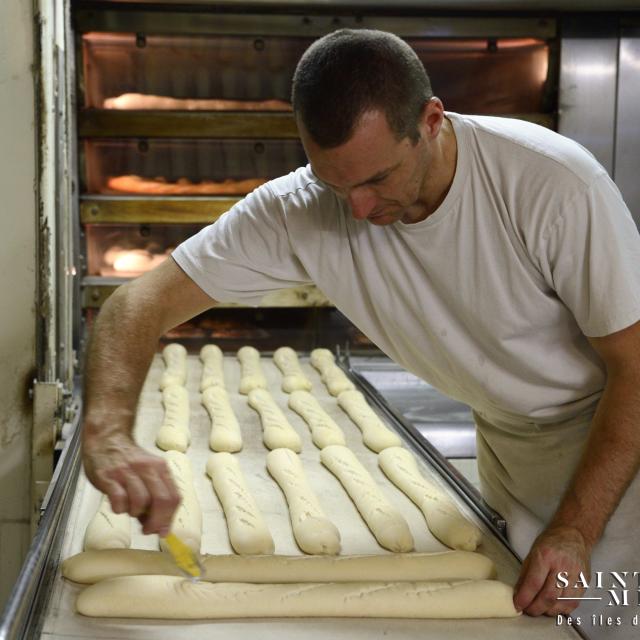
left=0, top=0, right=640, bottom=638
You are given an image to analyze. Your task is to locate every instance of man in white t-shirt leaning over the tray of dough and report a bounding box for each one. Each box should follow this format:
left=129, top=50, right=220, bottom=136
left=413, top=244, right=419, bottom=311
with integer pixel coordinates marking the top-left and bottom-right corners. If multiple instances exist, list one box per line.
left=84, top=30, right=640, bottom=615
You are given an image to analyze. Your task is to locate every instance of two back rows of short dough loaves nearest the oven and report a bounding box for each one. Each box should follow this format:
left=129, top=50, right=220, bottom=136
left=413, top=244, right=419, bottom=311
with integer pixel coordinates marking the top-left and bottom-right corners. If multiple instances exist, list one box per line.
left=156, top=343, right=401, bottom=453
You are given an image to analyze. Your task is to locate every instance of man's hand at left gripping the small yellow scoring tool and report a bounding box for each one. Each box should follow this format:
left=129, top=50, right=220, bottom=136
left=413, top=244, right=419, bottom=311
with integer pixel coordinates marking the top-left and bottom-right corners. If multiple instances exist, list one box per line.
left=83, top=433, right=180, bottom=536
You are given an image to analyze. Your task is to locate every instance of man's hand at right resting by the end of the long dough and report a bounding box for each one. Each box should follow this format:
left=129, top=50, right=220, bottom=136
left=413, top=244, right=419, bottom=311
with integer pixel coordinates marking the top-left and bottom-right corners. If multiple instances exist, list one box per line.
left=513, top=526, right=591, bottom=616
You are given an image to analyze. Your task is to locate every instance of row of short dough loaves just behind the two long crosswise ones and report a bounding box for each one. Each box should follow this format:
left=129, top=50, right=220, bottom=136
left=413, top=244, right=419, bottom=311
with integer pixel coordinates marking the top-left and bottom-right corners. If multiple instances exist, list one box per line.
left=84, top=445, right=481, bottom=554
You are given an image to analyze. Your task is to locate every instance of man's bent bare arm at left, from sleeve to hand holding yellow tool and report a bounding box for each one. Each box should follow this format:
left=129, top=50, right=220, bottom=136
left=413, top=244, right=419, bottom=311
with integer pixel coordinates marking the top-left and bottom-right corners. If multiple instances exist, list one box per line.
left=82, top=258, right=215, bottom=535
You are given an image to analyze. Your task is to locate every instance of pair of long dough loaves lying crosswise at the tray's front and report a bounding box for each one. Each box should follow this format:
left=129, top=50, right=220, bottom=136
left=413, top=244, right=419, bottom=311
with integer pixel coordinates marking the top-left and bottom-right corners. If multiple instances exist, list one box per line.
left=62, top=550, right=518, bottom=619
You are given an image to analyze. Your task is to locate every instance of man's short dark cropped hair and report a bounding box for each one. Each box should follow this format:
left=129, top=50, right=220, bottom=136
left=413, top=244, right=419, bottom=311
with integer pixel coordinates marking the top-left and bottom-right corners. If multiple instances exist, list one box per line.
left=291, top=29, right=433, bottom=149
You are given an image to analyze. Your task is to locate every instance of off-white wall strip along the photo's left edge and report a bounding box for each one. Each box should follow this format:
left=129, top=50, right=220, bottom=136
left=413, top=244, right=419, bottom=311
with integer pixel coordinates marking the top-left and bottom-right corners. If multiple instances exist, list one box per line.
left=0, top=0, right=37, bottom=609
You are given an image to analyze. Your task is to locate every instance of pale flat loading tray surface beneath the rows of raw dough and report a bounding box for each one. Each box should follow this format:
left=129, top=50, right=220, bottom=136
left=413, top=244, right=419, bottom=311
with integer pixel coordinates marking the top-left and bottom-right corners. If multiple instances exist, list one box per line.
left=0, top=352, right=578, bottom=640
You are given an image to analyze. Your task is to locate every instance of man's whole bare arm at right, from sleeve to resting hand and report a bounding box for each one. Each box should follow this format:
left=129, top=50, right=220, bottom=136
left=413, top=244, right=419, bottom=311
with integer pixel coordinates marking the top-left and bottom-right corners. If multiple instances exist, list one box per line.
left=514, top=322, right=640, bottom=615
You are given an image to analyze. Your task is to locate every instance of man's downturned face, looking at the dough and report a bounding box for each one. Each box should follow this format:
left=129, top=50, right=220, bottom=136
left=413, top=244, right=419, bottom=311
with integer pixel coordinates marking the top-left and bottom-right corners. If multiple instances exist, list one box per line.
left=299, top=111, right=429, bottom=225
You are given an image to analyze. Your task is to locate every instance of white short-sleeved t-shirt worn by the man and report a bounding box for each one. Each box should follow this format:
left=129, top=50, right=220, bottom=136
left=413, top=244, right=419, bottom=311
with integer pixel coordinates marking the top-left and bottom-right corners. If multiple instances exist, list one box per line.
left=173, top=113, right=640, bottom=425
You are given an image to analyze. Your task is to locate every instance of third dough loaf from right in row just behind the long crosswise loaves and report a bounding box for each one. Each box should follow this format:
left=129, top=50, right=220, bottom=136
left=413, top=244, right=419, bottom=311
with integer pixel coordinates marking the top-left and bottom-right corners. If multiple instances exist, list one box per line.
left=267, top=449, right=340, bottom=555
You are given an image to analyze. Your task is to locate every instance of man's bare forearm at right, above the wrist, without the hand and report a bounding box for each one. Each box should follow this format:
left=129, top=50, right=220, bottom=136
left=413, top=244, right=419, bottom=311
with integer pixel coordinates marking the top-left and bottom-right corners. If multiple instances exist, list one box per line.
left=548, top=370, right=640, bottom=547
